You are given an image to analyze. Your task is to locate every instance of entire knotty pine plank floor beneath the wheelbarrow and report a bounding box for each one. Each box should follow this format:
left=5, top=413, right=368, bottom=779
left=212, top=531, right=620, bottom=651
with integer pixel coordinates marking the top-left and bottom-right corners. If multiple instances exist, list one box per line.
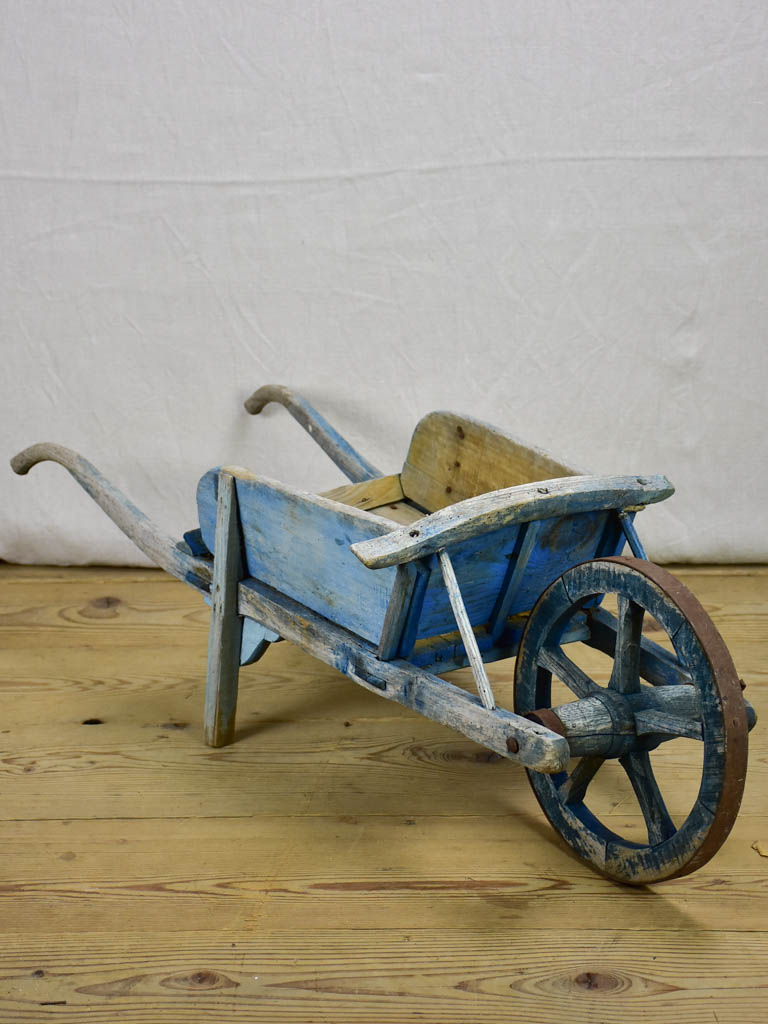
left=0, top=565, right=768, bottom=1024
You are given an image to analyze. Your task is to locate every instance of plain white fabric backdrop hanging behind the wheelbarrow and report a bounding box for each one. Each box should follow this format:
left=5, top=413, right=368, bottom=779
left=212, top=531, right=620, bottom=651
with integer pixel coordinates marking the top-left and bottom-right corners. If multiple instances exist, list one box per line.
left=0, top=0, right=768, bottom=563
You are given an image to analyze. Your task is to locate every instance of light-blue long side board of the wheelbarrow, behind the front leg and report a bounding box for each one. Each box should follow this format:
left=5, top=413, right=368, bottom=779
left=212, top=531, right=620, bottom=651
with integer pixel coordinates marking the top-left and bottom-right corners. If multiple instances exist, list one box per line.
left=198, top=470, right=395, bottom=643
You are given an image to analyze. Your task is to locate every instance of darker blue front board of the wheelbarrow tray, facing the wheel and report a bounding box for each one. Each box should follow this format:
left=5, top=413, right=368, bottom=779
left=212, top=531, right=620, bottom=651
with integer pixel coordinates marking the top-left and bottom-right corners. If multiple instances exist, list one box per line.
left=417, top=511, right=624, bottom=639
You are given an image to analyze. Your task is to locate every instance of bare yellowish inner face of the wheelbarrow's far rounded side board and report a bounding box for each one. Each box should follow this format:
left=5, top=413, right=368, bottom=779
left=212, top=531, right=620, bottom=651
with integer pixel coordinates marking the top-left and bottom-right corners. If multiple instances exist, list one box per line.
left=400, top=412, right=581, bottom=512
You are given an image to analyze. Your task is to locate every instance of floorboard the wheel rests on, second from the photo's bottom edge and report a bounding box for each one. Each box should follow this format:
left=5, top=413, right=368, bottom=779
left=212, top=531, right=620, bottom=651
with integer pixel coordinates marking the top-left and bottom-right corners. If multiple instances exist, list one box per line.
left=0, top=815, right=768, bottom=946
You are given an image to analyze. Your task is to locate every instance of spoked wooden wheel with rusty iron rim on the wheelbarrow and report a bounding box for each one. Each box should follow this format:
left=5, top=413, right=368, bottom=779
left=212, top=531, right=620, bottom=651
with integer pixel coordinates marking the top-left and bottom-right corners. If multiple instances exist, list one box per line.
left=515, top=558, right=754, bottom=885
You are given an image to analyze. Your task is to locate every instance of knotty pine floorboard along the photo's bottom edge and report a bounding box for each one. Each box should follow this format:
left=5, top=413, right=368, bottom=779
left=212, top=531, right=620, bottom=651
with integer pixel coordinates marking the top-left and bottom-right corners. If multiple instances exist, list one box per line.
left=0, top=919, right=768, bottom=1024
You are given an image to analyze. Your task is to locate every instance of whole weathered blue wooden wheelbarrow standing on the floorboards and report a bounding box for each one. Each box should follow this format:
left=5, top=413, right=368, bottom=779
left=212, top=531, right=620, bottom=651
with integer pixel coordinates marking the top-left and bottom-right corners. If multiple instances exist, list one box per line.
left=11, top=386, right=755, bottom=884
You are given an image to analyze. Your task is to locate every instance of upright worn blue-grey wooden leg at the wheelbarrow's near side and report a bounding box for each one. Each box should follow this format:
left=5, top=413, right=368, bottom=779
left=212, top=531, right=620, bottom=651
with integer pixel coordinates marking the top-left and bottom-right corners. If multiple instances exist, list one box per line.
left=204, top=473, right=243, bottom=746
